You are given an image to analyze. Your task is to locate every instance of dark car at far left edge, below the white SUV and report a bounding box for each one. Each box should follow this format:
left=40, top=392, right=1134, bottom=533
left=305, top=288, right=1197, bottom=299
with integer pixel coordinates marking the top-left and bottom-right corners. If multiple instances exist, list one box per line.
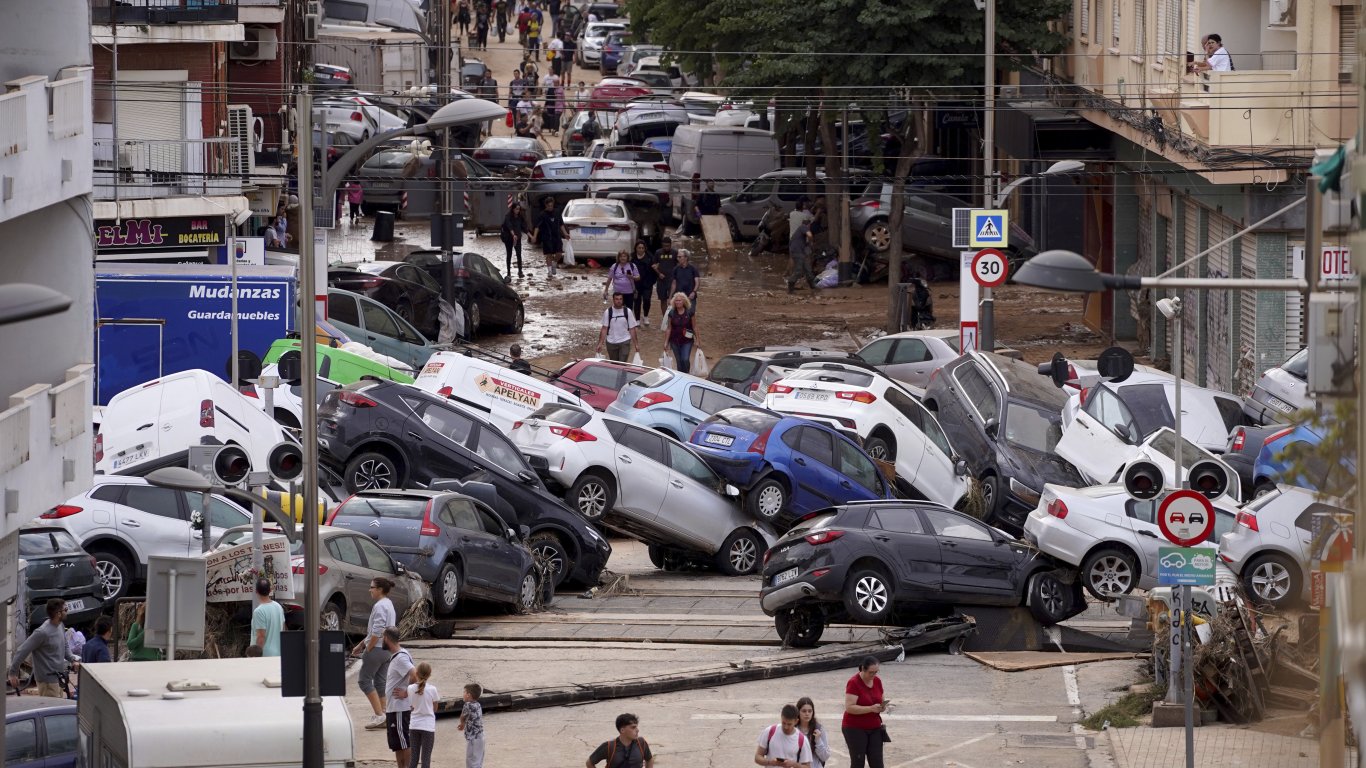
left=19, top=525, right=104, bottom=627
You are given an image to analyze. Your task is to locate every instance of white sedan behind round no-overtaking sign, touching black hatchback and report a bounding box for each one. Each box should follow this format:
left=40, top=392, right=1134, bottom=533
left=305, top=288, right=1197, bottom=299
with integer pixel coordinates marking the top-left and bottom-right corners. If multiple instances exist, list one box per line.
left=1025, top=482, right=1238, bottom=600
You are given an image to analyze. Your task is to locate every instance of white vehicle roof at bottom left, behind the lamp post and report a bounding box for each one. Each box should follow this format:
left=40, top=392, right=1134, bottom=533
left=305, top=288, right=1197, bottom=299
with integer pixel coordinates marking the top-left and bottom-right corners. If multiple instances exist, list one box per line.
left=76, top=657, right=357, bottom=768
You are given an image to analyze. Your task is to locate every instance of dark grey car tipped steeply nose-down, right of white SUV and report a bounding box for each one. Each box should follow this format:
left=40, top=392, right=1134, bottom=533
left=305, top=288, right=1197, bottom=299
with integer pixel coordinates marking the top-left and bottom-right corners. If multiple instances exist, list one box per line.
left=925, top=351, right=1087, bottom=533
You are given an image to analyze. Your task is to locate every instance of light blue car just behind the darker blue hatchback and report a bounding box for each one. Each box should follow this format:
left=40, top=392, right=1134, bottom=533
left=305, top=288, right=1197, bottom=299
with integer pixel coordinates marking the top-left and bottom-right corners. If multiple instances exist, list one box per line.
left=607, top=368, right=754, bottom=441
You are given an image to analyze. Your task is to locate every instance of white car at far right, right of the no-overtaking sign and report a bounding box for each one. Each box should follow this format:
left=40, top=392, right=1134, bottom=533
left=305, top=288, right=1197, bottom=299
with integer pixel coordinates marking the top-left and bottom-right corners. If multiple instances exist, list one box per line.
left=1218, top=485, right=1322, bottom=607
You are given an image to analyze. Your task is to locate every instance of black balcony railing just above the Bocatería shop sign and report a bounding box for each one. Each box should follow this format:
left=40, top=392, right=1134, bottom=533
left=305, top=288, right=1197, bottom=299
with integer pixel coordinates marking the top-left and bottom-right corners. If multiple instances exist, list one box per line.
left=94, top=138, right=242, bottom=200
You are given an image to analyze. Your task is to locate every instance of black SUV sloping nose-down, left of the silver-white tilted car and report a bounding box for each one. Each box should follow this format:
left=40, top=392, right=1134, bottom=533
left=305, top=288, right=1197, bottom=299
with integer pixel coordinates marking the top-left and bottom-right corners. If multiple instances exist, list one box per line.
left=318, top=380, right=612, bottom=585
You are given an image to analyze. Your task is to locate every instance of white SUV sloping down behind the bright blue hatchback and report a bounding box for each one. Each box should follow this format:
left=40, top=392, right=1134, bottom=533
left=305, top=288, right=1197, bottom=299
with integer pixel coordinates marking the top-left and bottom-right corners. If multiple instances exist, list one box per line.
left=764, top=362, right=968, bottom=507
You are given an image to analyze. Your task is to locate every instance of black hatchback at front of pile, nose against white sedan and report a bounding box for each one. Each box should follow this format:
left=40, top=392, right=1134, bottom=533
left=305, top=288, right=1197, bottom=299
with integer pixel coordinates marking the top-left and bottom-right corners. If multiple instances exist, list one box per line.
left=759, top=502, right=1086, bottom=646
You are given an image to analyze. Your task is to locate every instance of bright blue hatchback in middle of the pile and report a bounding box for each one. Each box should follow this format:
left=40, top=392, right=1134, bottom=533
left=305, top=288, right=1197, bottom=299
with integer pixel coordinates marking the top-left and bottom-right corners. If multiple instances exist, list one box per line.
left=691, top=406, right=893, bottom=526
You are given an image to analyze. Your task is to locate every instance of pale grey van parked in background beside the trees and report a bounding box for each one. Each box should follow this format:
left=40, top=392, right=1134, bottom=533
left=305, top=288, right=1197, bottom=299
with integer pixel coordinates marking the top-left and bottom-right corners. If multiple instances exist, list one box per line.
left=669, top=126, right=779, bottom=219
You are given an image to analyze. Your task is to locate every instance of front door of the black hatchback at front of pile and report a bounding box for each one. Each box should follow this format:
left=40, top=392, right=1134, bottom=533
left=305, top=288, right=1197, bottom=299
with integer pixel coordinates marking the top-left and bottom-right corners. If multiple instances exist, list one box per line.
left=921, top=507, right=1019, bottom=605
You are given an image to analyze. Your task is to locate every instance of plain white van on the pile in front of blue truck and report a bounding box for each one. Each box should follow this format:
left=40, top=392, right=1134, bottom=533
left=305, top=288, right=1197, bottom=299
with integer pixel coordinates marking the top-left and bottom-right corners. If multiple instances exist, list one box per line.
left=94, top=369, right=290, bottom=476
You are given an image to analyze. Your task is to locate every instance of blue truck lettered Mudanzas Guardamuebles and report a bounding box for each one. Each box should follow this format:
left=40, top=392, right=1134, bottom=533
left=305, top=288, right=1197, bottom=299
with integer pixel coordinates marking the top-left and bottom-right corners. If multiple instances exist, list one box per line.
left=94, top=262, right=298, bottom=406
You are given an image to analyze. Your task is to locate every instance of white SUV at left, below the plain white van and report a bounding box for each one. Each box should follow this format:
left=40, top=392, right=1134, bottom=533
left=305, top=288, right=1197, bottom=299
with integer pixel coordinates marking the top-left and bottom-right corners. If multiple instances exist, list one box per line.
left=37, top=474, right=251, bottom=604
